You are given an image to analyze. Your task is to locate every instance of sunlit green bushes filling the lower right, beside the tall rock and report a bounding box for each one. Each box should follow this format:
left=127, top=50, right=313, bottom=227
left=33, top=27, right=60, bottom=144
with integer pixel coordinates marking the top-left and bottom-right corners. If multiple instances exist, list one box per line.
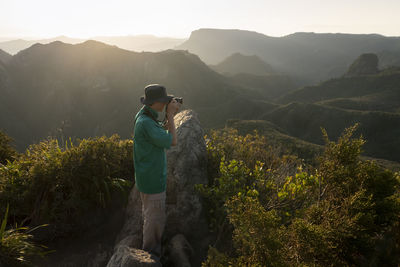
left=199, top=125, right=400, bottom=266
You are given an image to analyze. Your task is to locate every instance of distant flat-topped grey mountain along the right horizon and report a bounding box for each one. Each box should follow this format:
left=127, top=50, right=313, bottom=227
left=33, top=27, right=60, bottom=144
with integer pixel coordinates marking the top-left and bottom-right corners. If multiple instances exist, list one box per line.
left=177, top=29, right=400, bottom=84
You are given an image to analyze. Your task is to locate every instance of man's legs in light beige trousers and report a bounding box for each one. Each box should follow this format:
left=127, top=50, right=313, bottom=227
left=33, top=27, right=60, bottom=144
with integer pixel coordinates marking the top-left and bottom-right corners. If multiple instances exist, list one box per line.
left=140, top=192, right=166, bottom=257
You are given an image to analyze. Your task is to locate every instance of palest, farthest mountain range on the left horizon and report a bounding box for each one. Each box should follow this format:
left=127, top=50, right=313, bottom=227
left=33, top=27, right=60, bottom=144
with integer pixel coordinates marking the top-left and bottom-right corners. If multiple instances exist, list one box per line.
left=0, top=35, right=185, bottom=55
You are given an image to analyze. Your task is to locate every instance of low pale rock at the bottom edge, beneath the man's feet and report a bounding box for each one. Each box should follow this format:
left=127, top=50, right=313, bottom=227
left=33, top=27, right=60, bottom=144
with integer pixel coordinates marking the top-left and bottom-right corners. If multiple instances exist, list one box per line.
left=107, top=246, right=162, bottom=267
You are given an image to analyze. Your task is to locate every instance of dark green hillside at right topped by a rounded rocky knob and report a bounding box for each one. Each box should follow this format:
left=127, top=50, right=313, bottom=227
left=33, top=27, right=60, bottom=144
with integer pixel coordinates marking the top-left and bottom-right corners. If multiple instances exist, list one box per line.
left=262, top=54, right=400, bottom=161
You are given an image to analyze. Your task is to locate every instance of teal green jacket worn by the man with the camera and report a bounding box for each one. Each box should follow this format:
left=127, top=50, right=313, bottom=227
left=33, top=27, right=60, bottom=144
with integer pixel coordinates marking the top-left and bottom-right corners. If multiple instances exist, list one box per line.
left=133, top=106, right=172, bottom=194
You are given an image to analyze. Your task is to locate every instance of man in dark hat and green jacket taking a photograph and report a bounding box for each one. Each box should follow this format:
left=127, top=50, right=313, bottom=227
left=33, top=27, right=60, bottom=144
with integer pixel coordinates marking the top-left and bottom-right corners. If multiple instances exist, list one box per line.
left=133, top=84, right=180, bottom=258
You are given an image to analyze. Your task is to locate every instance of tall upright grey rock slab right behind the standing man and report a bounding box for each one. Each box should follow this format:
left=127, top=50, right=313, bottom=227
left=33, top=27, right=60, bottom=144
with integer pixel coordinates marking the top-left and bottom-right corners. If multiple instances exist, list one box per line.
left=164, top=110, right=208, bottom=243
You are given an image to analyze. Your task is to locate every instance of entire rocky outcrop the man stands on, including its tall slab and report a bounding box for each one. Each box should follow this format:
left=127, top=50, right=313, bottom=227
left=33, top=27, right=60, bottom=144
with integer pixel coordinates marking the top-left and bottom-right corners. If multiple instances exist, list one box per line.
left=107, top=110, right=209, bottom=267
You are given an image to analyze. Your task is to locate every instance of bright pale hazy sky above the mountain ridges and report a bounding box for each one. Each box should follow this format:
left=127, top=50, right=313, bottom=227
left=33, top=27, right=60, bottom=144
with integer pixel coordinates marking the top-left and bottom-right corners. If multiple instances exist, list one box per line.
left=0, top=0, right=400, bottom=40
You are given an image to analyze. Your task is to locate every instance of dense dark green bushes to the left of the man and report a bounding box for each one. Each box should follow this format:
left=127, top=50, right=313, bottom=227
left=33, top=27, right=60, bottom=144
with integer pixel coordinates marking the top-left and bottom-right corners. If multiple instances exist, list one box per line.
left=0, top=134, right=133, bottom=233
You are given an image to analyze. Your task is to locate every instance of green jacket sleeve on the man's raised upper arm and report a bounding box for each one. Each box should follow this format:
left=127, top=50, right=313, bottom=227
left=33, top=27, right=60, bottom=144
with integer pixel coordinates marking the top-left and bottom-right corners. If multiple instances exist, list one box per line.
left=143, top=120, right=172, bottom=148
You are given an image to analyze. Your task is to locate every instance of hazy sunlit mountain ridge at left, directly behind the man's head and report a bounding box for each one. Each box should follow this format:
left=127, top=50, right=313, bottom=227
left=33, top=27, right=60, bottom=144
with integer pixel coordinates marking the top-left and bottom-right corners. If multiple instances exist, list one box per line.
left=0, top=41, right=275, bottom=151
